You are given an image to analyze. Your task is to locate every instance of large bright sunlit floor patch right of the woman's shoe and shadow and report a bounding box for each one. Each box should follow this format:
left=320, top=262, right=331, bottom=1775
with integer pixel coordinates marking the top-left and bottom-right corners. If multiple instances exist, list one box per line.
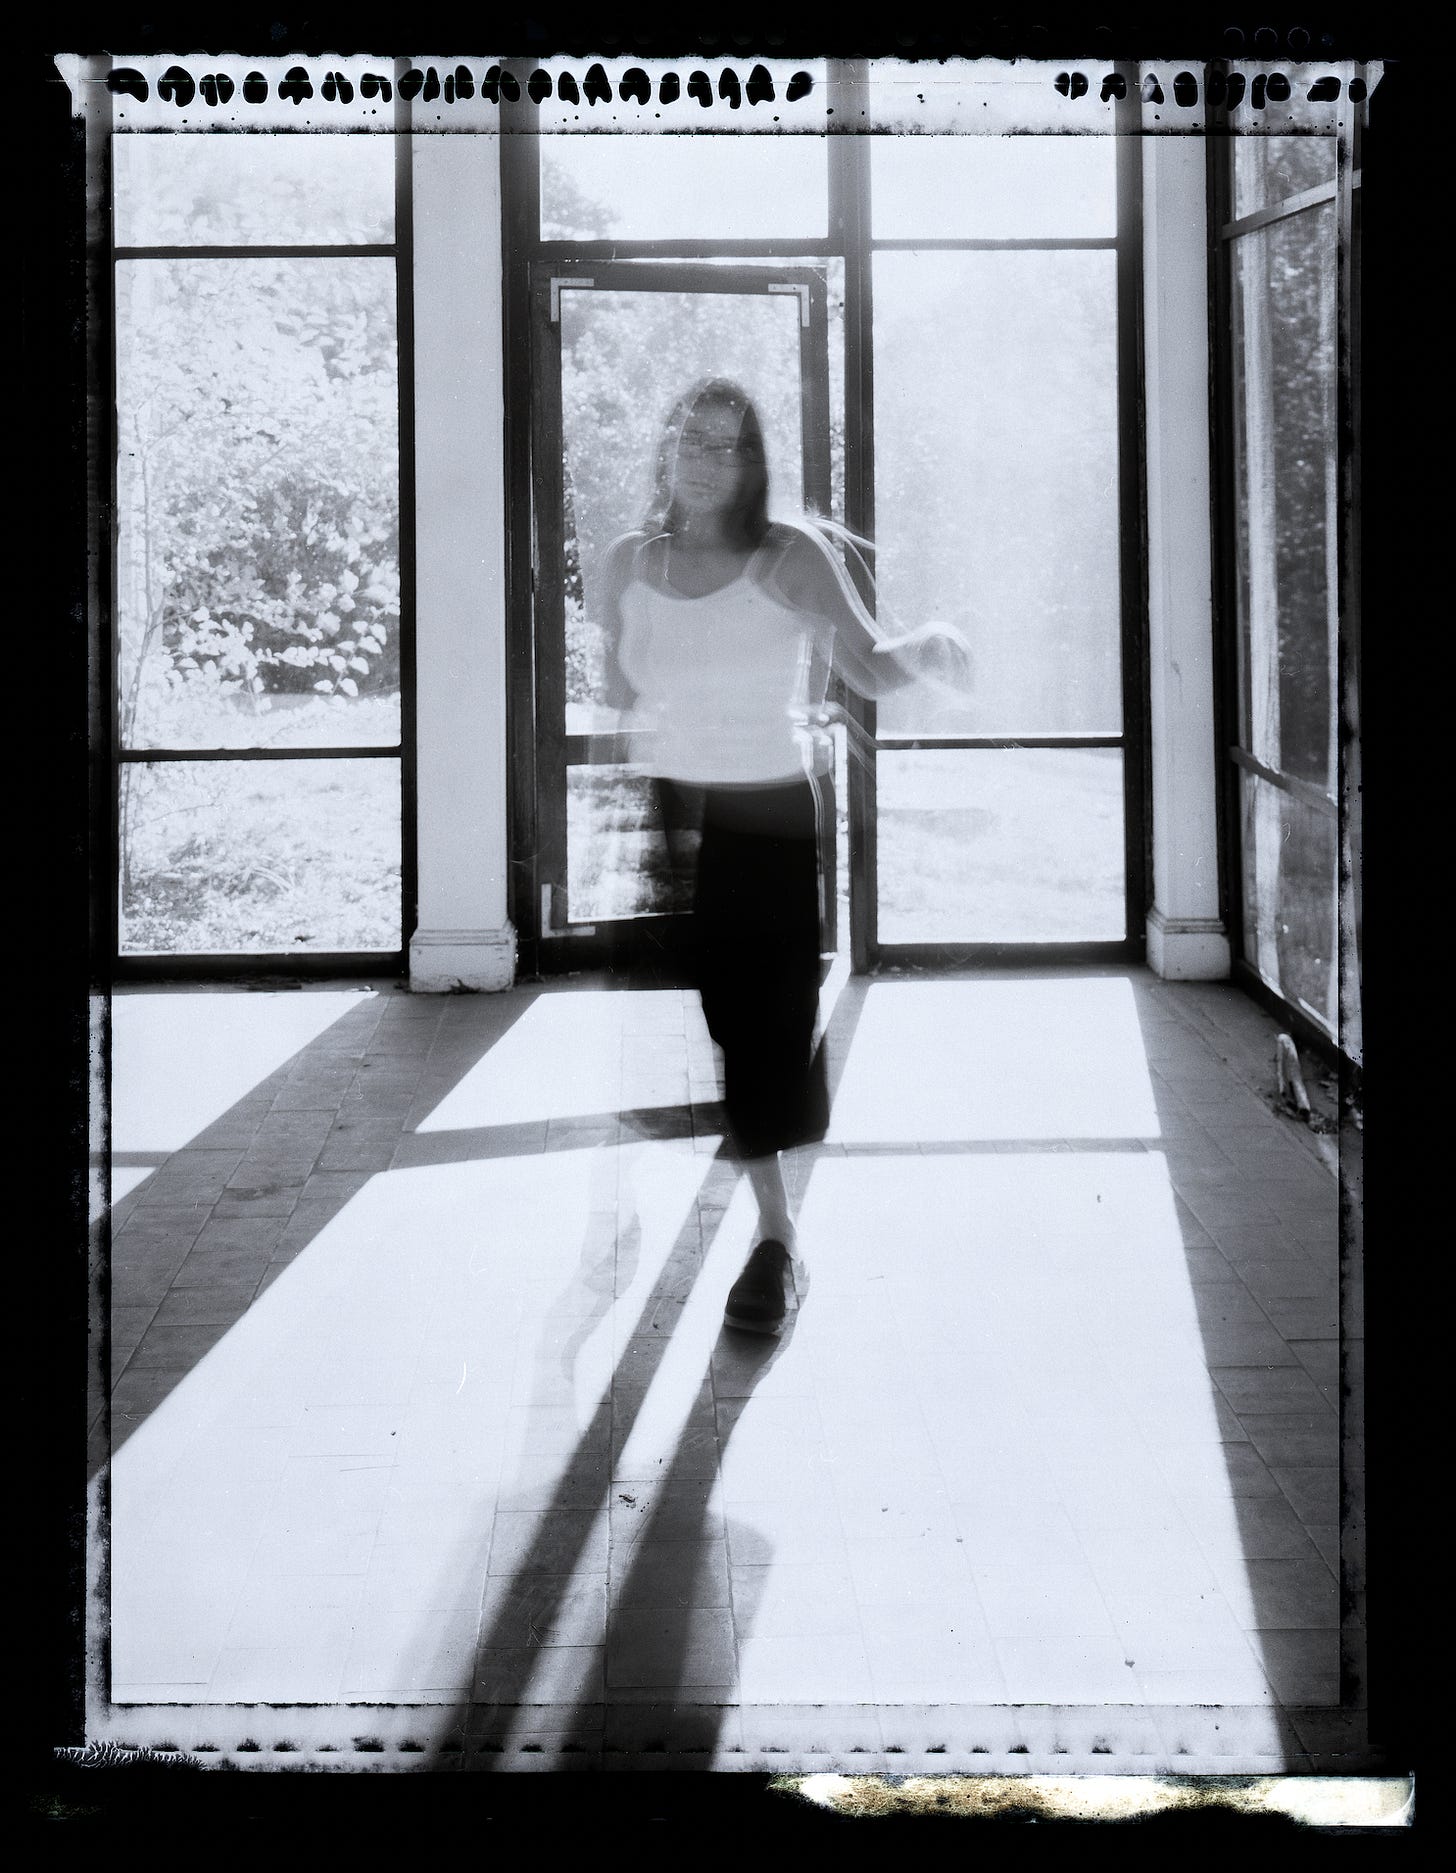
left=794, top=1152, right=1270, bottom=1704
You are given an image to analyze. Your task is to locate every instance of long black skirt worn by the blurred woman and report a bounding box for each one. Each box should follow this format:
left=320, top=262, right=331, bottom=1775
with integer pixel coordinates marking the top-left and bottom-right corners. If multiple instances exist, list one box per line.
left=658, top=777, right=832, bottom=1158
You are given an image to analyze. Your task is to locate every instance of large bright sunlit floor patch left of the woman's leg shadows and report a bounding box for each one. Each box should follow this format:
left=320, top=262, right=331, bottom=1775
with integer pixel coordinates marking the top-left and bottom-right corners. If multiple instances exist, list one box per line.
left=111, top=1150, right=706, bottom=1703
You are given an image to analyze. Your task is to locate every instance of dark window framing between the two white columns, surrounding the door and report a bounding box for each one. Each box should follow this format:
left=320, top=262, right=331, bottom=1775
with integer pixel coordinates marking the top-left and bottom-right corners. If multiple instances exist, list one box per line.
left=500, top=60, right=1152, bottom=976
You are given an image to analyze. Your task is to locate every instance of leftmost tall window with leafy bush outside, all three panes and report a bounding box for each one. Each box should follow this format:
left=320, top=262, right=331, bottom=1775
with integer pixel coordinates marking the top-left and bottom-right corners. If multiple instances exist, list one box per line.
left=111, top=135, right=405, bottom=963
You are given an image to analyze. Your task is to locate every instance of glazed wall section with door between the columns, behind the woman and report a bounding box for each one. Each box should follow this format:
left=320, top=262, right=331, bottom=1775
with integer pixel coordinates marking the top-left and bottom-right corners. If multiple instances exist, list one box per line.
left=506, top=113, right=1143, bottom=968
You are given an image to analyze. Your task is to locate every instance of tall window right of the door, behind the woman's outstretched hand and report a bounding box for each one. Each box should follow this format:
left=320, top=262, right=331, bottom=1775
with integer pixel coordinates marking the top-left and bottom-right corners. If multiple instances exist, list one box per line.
left=856, top=124, right=1145, bottom=966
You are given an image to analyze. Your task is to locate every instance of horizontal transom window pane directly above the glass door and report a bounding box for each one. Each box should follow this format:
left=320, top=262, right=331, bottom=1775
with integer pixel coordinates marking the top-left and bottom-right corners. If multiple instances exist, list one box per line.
left=540, top=135, right=828, bottom=240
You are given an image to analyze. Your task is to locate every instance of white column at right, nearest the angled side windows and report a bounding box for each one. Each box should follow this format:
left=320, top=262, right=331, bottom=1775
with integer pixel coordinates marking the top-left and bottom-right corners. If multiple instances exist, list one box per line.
left=1141, top=135, right=1229, bottom=980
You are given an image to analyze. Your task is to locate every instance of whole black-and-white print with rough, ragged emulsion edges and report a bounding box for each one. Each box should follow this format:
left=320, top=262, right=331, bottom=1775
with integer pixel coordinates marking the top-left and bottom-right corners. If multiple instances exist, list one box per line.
left=28, top=17, right=1411, bottom=1830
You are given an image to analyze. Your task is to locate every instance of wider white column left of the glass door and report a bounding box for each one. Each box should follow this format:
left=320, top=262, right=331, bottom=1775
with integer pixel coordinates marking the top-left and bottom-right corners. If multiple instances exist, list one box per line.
left=410, top=131, right=515, bottom=989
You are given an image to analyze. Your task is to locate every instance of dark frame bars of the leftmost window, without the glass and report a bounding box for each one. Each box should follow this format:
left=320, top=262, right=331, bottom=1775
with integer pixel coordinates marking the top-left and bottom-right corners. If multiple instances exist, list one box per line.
left=103, top=100, right=418, bottom=983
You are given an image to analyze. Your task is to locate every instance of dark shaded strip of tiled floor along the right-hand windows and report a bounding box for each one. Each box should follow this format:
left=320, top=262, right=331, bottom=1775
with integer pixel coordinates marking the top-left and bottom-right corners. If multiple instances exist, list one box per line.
left=1136, top=983, right=1340, bottom=1706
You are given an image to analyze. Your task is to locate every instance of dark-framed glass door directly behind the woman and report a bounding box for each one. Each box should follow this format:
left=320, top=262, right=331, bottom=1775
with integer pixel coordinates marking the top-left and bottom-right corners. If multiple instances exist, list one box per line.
left=532, top=262, right=838, bottom=970
